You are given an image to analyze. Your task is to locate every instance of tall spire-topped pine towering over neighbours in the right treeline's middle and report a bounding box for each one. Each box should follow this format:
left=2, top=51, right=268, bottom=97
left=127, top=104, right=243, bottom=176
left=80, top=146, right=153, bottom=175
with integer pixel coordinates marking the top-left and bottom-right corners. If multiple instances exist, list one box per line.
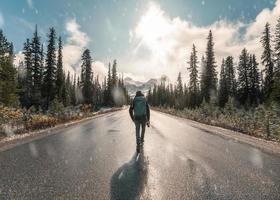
left=201, top=30, right=217, bottom=102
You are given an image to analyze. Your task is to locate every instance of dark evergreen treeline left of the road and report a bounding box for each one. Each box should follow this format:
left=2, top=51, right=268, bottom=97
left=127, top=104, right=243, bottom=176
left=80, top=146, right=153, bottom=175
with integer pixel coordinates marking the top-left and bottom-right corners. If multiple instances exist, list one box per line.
left=0, top=25, right=129, bottom=111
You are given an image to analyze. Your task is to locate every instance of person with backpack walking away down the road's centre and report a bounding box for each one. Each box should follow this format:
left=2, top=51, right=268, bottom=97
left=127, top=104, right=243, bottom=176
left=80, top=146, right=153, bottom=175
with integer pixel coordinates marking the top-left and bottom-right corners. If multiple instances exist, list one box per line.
left=129, top=91, right=150, bottom=153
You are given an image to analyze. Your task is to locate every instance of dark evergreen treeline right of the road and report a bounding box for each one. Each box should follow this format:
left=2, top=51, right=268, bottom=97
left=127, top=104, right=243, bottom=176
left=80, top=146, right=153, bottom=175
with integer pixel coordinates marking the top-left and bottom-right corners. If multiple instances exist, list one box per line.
left=147, top=18, right=280, bottom=110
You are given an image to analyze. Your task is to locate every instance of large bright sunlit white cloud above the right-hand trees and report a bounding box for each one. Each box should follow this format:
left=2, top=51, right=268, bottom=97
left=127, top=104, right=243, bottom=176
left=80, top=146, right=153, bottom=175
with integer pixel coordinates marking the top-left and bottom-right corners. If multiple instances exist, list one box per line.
left=123, top=0, right=280, bottom=81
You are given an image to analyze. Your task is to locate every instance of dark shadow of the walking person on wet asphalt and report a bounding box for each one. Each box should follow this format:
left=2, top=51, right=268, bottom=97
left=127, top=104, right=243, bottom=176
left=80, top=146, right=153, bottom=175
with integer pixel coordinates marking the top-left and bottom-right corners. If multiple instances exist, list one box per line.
left=111, top=149, right=148, bottom=200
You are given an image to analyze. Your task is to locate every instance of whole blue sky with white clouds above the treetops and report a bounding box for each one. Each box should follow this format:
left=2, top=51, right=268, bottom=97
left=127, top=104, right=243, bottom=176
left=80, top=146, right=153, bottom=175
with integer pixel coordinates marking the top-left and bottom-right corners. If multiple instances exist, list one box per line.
left=0, top=0, right=280, bottom=82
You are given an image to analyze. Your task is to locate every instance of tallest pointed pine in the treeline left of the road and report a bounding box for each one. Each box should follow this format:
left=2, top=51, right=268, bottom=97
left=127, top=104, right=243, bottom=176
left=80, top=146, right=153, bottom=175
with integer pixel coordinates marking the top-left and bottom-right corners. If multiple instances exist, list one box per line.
left=31, top=25, right=42, bottom=109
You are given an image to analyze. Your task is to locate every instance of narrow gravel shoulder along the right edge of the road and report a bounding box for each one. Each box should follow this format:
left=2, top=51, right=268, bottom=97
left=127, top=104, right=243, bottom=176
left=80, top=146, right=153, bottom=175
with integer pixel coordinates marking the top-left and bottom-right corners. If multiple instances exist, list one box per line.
left=152, top=109, right=280, bottom=156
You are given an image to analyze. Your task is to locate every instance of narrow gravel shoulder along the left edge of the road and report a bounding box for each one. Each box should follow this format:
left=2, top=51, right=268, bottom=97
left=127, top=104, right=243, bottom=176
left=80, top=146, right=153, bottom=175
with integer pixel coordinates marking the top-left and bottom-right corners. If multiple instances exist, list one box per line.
left=0, top=108, right=126, bottom=153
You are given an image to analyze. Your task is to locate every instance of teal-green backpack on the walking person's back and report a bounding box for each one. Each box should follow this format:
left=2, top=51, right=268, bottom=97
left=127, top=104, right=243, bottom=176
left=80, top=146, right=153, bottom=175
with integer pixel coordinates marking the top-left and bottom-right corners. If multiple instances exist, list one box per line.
left=133, top=96, right=147, bottom=120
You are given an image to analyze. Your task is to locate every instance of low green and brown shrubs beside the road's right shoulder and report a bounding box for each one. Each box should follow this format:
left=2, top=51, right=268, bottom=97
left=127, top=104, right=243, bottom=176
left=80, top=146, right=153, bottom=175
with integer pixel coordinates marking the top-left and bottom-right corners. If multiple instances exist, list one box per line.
left=156, top=101, right=280, bottom=141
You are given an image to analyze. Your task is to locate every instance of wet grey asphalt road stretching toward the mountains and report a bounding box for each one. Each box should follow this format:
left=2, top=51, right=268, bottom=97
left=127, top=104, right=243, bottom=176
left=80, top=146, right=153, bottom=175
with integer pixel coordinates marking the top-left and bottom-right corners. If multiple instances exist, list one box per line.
left=0, top=110, right=280, bottom=200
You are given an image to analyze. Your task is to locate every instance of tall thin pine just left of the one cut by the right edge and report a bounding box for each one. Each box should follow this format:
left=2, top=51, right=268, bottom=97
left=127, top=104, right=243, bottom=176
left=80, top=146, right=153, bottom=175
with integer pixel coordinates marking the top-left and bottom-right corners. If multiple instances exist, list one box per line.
left=261, top=23, right=274, bottom=102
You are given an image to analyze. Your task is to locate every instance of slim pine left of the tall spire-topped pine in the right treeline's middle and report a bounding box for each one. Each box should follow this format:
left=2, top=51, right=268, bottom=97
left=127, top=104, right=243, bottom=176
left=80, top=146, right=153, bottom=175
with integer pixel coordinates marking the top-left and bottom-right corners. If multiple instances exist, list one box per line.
left=188, top=45, right=199, bottom=108
